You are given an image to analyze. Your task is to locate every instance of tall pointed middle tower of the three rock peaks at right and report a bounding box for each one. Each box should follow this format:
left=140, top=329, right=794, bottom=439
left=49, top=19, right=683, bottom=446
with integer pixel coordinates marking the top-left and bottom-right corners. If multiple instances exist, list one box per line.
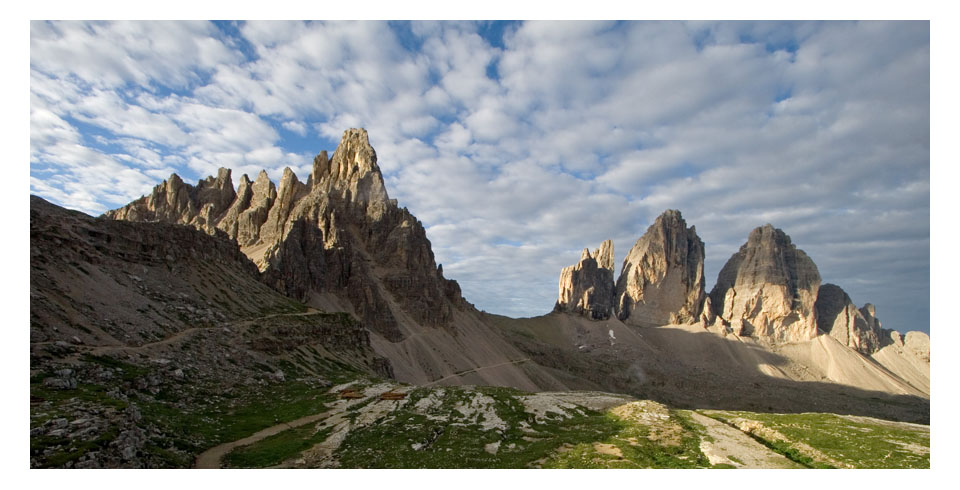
left=616, top=210, right=706, bottom=325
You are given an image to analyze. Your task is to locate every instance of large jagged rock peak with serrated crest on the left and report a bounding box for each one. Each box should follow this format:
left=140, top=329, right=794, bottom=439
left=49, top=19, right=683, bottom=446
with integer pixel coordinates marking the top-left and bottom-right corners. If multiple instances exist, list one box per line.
left=106, top=129, right=468, bottom=341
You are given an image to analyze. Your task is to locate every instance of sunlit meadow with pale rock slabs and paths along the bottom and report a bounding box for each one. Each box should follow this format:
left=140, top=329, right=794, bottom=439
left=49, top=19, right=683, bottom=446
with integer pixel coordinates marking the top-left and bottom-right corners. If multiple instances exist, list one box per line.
left=196, top=380, right=930, bottom=468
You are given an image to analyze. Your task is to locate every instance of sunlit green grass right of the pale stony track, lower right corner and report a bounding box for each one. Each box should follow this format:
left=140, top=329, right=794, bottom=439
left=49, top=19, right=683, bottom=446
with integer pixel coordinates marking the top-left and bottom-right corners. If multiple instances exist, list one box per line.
left=702, top=411, right=930, bottom=468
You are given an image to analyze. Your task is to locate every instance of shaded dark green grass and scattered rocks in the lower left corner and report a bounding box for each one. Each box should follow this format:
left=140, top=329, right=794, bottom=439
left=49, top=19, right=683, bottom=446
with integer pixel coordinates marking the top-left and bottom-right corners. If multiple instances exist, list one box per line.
left=30, top=348, right=361, bottom=468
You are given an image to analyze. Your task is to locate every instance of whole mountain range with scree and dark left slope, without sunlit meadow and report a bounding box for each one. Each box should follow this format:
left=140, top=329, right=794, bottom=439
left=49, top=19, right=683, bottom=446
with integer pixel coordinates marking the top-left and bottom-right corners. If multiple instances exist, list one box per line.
left=30, top=129, right=930, bottom=467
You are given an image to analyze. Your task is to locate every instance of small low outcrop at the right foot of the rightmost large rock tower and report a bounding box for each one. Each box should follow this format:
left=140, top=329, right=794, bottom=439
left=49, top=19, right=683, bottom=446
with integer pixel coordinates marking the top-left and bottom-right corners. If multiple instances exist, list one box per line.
left=814, top=284, right=883, bottom=355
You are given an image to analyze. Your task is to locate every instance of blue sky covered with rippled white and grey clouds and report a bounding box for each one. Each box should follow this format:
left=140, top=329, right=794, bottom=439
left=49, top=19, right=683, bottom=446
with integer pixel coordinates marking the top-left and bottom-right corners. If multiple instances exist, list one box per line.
left=30, top=21, right=930, bottom=331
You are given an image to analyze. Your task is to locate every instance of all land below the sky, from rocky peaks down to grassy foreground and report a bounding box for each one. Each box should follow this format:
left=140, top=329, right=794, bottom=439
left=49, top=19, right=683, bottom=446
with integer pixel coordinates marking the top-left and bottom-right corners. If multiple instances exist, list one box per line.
left=30, top=129, right=930, bottom=468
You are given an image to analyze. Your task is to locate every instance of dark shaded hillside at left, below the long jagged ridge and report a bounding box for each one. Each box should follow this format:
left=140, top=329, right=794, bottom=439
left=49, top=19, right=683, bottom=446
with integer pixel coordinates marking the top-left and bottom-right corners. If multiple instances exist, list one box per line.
left=30, top=197, right=391, bottom=468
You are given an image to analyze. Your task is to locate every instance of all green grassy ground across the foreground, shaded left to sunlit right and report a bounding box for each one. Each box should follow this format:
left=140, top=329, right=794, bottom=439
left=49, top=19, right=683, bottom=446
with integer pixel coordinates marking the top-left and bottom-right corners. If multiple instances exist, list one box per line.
left=31, top=349, right=930, bottom=468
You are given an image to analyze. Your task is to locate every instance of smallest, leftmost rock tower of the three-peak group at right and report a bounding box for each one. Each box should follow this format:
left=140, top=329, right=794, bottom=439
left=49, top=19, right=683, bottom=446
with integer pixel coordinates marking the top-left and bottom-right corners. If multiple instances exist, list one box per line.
left=554, top=240, right=614, bottom=320
